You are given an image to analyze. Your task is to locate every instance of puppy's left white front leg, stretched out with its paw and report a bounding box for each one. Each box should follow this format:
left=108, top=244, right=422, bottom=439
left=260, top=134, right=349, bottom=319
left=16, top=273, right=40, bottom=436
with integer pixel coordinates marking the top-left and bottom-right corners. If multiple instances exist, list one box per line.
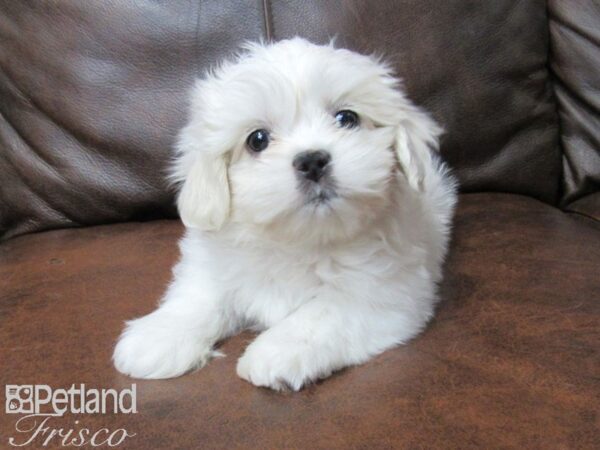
left=113, top=250, right=233, bottom=378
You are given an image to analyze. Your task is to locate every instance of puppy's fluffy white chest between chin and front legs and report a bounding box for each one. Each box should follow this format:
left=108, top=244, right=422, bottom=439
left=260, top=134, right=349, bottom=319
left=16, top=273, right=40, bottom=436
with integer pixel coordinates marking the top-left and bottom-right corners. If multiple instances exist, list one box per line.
left=214, top=243, right=394, bottom=326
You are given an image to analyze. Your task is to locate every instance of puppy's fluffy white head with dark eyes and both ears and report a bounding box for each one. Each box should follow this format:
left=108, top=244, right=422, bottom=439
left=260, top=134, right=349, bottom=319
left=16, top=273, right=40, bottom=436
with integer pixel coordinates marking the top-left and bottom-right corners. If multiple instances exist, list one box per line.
left=173, top=38, right=440, bottom=242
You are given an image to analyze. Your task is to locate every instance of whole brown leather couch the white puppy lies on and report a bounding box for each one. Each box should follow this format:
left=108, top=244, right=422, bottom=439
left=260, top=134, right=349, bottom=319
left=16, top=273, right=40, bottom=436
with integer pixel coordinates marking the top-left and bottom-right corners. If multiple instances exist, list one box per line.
left=0, top=0, right=600, bottom=449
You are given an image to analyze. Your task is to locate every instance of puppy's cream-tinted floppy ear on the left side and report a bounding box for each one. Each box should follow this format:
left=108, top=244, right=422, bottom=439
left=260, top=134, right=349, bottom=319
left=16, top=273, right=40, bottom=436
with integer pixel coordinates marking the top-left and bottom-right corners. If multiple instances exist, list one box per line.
left=177, top=154, right=230, bottom=231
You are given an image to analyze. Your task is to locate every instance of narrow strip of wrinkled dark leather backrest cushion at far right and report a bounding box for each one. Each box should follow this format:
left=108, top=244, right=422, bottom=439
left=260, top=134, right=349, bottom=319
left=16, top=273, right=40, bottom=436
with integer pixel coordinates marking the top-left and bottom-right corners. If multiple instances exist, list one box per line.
left=548, top=0, right=600, bottom=220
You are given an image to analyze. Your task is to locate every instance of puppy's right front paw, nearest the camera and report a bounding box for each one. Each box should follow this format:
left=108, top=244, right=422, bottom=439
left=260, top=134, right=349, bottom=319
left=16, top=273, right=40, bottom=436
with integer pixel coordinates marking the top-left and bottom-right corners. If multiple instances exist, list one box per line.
left=237, top=335, right=332, bottom=391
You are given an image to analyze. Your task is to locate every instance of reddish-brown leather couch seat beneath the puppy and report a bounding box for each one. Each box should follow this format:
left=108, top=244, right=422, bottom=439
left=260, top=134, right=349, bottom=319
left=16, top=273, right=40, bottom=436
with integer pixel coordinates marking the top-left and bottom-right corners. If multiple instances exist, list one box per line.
left=0, top=194, right=600, bottom=449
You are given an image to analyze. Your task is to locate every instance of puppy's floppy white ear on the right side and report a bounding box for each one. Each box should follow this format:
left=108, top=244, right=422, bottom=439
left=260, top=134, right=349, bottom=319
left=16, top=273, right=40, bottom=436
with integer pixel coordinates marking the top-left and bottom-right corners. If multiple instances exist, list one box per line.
left=396, top=109, right=442, bottom=191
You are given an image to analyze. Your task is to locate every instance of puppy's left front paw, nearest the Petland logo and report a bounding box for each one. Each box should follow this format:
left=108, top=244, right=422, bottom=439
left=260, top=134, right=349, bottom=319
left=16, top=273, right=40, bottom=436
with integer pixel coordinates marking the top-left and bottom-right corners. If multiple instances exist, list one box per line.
left=113, top=312, right=218, bottom=379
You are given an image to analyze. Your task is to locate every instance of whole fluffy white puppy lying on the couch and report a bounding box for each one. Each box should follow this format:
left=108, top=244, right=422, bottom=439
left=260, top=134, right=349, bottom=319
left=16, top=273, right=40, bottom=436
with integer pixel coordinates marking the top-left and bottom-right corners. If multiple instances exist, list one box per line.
left=114, top=38, right=456, bottom=390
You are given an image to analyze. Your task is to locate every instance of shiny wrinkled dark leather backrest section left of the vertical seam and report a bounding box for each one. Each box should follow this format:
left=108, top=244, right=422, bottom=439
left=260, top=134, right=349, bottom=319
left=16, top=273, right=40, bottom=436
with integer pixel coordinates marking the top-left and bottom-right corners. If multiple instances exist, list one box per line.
left=0, top=0, right=264, bottom=238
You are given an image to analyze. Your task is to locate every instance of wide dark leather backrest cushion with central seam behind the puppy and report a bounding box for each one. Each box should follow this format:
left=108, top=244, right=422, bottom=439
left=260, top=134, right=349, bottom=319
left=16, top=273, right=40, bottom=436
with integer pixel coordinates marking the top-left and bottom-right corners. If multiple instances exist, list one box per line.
left=0, top=0, right=561, bottom=239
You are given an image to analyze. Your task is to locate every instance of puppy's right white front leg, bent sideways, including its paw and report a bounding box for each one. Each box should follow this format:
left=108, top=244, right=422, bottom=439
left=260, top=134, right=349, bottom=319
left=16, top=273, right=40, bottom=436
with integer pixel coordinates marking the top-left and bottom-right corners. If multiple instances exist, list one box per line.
left=237, top=299, right=418, bottom=390
